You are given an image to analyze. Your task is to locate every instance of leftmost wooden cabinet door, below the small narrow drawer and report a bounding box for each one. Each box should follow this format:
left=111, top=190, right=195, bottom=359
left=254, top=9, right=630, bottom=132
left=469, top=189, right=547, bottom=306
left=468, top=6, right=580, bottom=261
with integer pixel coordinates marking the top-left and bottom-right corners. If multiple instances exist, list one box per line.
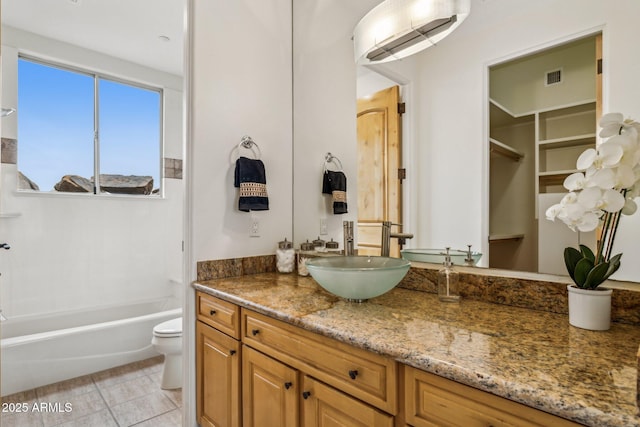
left=196, top=321, right=241, bottom=427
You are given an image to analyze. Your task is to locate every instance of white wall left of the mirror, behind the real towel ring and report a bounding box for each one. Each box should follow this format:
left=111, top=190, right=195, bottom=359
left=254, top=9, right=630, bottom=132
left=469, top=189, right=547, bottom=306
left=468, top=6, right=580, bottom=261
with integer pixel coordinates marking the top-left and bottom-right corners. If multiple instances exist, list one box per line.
left=190, top=0, right=293, bottom=261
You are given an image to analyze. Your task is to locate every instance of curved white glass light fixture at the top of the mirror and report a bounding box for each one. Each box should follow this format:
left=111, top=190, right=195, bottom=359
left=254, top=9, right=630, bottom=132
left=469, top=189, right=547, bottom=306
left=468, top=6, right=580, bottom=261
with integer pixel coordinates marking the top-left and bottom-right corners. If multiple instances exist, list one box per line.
left=353, top=0, right=470, bottom=64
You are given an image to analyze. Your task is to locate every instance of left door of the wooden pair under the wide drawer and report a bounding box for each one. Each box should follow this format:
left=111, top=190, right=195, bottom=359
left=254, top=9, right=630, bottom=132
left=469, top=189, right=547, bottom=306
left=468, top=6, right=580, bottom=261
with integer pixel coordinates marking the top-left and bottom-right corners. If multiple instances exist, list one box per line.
left=242, top=345, right=300, bottom=427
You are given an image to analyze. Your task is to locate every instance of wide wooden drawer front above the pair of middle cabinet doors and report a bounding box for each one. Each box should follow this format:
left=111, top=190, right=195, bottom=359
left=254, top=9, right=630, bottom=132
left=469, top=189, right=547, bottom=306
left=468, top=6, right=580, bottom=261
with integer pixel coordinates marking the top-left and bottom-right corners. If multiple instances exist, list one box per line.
left=242, top=309, right=397, bottom=415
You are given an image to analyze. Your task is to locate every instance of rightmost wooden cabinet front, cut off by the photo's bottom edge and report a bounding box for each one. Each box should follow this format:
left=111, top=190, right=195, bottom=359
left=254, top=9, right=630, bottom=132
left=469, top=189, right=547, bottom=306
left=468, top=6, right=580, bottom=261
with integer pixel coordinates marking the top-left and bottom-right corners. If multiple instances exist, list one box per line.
left=402, top=366, right=579, bottom=427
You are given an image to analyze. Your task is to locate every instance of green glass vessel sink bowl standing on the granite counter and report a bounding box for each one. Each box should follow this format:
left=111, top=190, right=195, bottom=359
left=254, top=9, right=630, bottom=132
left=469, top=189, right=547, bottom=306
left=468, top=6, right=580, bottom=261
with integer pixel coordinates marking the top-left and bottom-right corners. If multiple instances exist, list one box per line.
left=306, top=256, right=411, bottom=302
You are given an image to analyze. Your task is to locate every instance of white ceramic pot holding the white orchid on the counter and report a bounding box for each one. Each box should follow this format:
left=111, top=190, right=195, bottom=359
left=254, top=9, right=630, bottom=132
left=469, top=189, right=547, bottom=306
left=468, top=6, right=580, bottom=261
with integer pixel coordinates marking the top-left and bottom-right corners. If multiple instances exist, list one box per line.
left=567, top=285, right=613, bottom=331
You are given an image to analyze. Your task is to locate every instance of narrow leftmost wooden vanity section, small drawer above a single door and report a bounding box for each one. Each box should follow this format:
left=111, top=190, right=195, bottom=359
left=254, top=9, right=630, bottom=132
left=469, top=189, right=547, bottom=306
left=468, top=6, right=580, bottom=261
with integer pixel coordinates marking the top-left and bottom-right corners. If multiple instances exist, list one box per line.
left=196, top=293, right=242, bottom=427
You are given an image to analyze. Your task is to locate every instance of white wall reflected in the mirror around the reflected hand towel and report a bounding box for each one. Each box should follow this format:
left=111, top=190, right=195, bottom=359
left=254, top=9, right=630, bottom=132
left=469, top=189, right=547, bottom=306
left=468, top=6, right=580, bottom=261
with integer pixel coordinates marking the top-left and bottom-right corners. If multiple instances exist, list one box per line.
left=293, top=0, right=379, bottom=247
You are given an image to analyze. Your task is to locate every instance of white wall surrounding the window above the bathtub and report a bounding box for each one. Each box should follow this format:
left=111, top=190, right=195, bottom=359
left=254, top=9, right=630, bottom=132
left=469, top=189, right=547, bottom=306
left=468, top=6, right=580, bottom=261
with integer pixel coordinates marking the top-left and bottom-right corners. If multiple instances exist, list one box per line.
left=0, top=28, right=183, bottom=317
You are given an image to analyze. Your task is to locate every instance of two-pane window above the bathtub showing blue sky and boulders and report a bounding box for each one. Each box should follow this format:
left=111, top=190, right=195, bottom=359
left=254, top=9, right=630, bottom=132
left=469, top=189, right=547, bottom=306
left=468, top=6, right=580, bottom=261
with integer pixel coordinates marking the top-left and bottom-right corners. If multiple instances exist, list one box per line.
left=18, top=57, right=162, bottom=194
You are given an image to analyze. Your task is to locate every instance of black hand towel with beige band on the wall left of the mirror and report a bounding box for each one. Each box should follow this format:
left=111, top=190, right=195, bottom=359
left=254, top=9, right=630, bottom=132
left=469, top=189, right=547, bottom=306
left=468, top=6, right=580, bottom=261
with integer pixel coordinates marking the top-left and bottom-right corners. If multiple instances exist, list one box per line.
left=234, top=157, right=269, bottom=212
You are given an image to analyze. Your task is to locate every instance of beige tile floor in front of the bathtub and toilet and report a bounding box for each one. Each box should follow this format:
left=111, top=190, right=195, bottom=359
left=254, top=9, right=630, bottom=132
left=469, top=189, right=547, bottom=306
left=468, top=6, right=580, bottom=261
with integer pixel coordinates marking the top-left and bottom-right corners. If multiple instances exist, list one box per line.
left=0, top=356, right=182, bottom=427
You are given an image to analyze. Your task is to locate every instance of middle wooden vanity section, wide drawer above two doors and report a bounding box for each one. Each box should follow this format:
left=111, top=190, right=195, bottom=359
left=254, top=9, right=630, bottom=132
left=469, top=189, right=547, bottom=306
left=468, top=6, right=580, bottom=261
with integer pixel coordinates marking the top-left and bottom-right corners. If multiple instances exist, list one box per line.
left=241, top=309, right=397, bottom=427
